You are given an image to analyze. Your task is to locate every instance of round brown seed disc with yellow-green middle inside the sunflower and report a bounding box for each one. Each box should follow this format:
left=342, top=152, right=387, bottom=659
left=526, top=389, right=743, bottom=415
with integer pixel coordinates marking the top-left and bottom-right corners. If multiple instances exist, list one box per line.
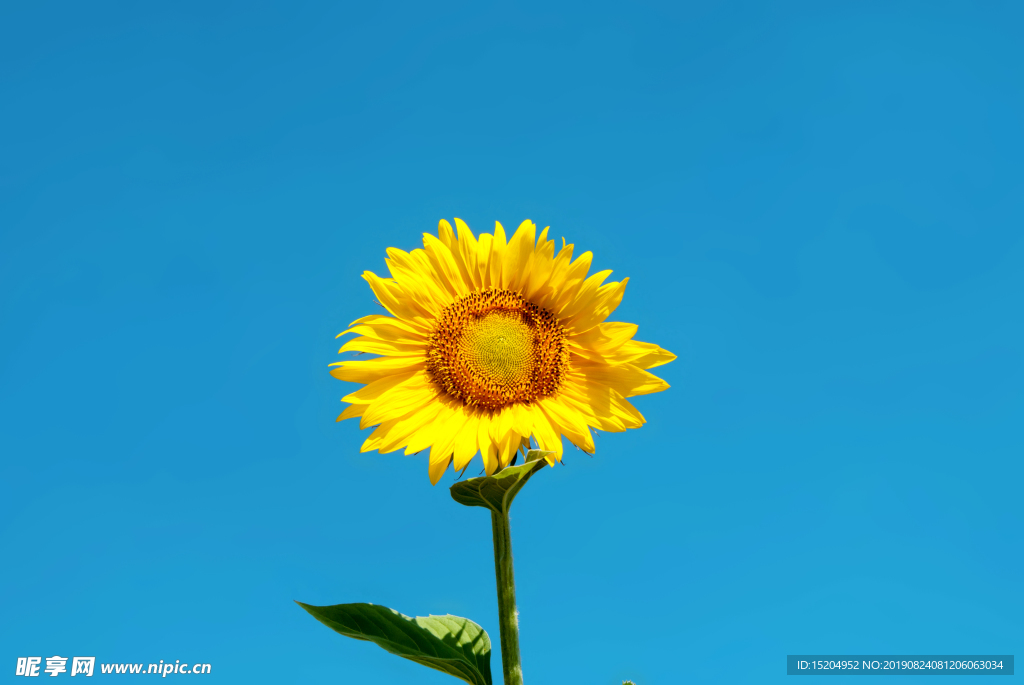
left=427, top=290, right=569, bottom=410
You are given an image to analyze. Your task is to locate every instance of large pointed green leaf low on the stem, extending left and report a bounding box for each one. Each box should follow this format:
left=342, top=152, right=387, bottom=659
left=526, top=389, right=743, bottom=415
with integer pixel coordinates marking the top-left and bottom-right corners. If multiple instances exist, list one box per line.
left=296, top=602, right=490, bottom=685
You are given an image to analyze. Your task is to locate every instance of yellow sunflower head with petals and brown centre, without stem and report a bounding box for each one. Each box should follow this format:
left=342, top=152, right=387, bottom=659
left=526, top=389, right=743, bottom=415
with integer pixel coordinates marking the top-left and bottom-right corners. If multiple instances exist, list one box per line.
left=331, top=219, right=676, bottom=484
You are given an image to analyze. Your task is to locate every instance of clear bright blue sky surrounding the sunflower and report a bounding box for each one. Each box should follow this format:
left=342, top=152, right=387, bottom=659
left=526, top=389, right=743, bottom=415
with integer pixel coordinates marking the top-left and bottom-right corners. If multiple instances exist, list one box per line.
left=0, top=2, right=1024, bottom=685
